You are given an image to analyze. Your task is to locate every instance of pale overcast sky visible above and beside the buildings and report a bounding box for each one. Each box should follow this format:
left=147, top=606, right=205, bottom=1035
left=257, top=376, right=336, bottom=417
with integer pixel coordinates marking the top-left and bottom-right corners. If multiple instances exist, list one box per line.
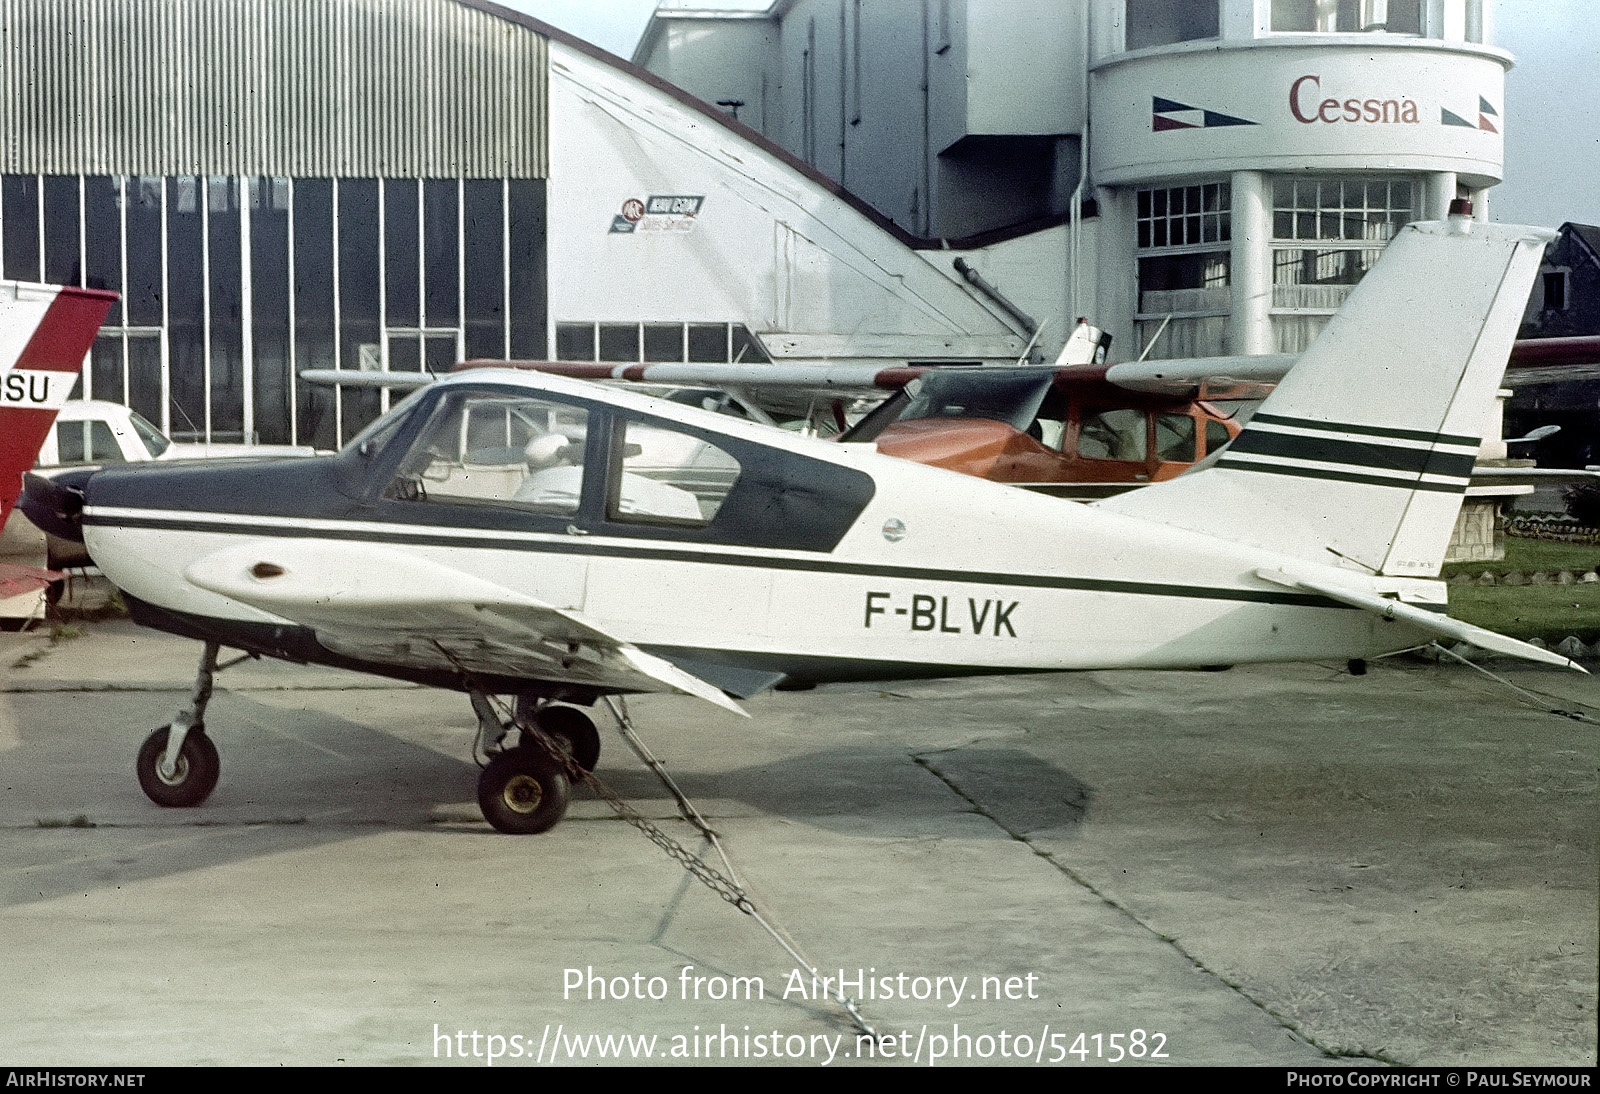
left=498, top=0, right=1600, bottom=227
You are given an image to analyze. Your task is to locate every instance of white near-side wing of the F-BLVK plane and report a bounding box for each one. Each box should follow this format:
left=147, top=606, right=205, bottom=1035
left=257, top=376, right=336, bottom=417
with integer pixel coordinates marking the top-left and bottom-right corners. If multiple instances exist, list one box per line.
left=184, top=539, right=744, bottom=715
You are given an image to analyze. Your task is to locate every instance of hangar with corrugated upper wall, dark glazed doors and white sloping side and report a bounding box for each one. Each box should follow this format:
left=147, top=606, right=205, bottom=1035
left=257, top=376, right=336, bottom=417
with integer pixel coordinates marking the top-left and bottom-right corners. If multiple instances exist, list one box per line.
left=0, top=0, right=1027, bottom=446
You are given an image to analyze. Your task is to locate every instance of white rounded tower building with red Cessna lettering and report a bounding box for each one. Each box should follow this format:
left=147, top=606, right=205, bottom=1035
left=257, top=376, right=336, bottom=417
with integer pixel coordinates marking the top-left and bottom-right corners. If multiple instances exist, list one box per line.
left=1086, top=0, right=1510, bottom=357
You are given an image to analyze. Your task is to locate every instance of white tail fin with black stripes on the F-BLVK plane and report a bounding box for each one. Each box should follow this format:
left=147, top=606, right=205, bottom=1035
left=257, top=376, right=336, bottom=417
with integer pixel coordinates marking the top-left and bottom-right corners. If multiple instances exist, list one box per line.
left=1099, top=218, right=1554, bottom=577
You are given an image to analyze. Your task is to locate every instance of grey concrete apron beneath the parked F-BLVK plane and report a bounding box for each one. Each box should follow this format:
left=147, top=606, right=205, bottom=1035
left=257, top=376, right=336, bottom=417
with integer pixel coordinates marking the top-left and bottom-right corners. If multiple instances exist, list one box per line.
left=0, top=624, right=1600, bottom=1065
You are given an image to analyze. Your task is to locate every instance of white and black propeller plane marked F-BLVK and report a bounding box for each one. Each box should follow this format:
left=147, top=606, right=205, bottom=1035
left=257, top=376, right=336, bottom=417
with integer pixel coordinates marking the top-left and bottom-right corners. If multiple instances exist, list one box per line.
left=26, top=218, right=1576, bottom=832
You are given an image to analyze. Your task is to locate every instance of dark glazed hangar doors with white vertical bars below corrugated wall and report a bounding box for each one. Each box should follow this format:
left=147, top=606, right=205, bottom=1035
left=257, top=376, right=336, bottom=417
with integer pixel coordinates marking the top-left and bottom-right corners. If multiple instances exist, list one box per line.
left=0, top=174, right=547, bottom=448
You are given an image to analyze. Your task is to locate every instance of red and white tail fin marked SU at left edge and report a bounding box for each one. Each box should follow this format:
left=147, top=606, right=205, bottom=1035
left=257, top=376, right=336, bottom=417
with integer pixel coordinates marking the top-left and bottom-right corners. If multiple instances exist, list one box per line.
left=0, top=281, right=117, bottom=526
